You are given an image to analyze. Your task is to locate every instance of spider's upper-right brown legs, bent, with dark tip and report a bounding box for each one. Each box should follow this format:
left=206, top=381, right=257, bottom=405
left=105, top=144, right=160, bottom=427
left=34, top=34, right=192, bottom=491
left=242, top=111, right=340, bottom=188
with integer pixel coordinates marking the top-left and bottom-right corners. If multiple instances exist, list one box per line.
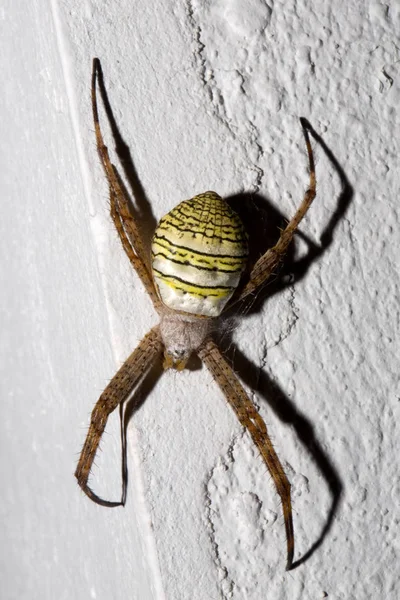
left=235, top=119, right=316, bottom=302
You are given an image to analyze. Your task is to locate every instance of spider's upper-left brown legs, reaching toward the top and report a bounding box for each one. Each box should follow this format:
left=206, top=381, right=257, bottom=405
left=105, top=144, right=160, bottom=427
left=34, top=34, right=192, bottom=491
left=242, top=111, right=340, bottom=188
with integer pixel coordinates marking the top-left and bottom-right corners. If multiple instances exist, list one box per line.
left=91, top=58, right=162, bottom=311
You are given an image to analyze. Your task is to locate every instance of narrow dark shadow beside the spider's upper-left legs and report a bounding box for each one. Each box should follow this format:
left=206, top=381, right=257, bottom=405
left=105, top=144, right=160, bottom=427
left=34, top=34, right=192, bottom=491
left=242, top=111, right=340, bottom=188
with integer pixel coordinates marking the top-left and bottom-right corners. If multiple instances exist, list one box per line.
left=97, top=58, right=157, bottom=251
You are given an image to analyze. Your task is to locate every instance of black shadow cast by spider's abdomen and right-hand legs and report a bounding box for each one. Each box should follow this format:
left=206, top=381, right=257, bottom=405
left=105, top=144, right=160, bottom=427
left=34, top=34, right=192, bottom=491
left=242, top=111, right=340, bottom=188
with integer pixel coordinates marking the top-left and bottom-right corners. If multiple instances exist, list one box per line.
left=219, top=121, right=354, bottom=568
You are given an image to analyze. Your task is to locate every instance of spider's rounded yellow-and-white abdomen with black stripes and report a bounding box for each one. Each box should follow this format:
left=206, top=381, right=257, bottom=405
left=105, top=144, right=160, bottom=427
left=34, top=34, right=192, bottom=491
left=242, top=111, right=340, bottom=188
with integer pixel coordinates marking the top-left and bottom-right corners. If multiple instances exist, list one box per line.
left=151, top=192, right=248, bottom=317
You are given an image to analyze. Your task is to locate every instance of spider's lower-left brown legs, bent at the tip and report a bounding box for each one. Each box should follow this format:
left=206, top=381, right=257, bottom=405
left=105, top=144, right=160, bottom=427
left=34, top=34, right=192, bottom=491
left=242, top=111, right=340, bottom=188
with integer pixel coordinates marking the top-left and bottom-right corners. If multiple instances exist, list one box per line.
left=75, top=326, right=163, bottom=506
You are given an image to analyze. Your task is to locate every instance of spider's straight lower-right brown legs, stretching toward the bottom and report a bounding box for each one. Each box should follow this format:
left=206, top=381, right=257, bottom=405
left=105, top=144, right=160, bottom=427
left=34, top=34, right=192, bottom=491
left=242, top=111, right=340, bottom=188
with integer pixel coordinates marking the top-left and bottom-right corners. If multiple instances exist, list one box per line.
left=198, top=340, right=294, bottom=570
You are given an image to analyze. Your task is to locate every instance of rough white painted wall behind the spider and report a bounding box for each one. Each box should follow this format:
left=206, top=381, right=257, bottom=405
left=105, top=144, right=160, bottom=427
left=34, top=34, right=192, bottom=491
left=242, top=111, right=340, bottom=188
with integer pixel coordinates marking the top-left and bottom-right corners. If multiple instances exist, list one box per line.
left=0, top=0, right=400, bottom=600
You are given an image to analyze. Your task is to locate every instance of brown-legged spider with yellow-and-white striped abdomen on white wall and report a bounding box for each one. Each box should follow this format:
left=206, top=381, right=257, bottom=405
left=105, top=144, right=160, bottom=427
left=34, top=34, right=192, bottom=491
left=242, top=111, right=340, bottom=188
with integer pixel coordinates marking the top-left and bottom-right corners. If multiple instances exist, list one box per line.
left=75, top=58, right=316, bottom=570
